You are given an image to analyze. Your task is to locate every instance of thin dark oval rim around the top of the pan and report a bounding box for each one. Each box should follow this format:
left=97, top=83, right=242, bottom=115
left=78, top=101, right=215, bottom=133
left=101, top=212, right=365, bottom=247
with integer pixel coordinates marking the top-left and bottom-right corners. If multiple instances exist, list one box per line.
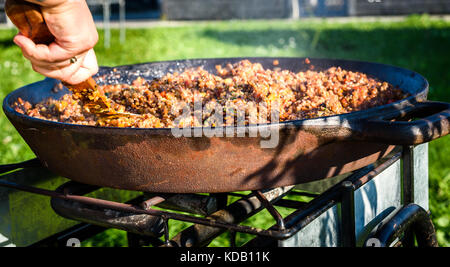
left=3, top=57, right=429, bottom=134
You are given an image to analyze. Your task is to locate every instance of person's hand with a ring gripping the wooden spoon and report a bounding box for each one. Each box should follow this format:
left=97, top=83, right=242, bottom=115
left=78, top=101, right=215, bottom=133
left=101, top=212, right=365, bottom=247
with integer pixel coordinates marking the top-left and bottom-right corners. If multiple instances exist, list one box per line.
left=14, top=0, right=98, bottom=84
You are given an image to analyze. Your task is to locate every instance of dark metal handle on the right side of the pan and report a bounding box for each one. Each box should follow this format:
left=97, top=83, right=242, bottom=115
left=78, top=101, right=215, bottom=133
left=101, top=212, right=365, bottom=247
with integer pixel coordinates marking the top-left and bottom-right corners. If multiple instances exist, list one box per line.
left=351, top=101, right=450, bottom=145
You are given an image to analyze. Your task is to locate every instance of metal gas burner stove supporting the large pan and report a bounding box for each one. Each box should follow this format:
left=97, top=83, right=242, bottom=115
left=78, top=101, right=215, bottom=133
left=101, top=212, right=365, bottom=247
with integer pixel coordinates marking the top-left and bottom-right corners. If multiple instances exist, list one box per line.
left=0, top=144, right=437, bottom=247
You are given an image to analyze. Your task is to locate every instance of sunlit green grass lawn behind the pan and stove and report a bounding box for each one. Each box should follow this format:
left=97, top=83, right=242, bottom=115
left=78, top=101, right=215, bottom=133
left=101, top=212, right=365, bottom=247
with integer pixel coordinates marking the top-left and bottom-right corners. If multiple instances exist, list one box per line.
left=0, top=16, right=450, bottom=246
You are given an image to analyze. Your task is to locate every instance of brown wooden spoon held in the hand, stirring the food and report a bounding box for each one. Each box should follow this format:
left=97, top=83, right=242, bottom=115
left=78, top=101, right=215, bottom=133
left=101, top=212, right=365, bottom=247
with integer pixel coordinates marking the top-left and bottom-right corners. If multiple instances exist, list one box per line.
left=5, top=0, right=138, bottom=117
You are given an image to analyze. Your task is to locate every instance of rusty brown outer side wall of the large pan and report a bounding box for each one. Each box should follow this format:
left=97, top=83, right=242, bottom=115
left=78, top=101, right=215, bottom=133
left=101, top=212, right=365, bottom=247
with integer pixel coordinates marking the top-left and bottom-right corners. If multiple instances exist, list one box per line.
left=5, top=117, right=394, bottom=193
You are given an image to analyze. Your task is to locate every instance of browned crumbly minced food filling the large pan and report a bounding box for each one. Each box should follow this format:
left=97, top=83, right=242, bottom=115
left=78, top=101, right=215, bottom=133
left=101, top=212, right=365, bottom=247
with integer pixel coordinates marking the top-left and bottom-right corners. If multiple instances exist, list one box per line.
left=14, top=60, right=406, bottom=128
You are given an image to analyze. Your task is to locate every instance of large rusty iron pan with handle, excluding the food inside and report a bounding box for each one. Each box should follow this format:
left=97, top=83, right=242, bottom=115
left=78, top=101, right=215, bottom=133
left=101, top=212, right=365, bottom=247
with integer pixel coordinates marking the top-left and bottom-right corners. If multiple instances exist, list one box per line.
left=3, top=58, right=450, bottom=193
